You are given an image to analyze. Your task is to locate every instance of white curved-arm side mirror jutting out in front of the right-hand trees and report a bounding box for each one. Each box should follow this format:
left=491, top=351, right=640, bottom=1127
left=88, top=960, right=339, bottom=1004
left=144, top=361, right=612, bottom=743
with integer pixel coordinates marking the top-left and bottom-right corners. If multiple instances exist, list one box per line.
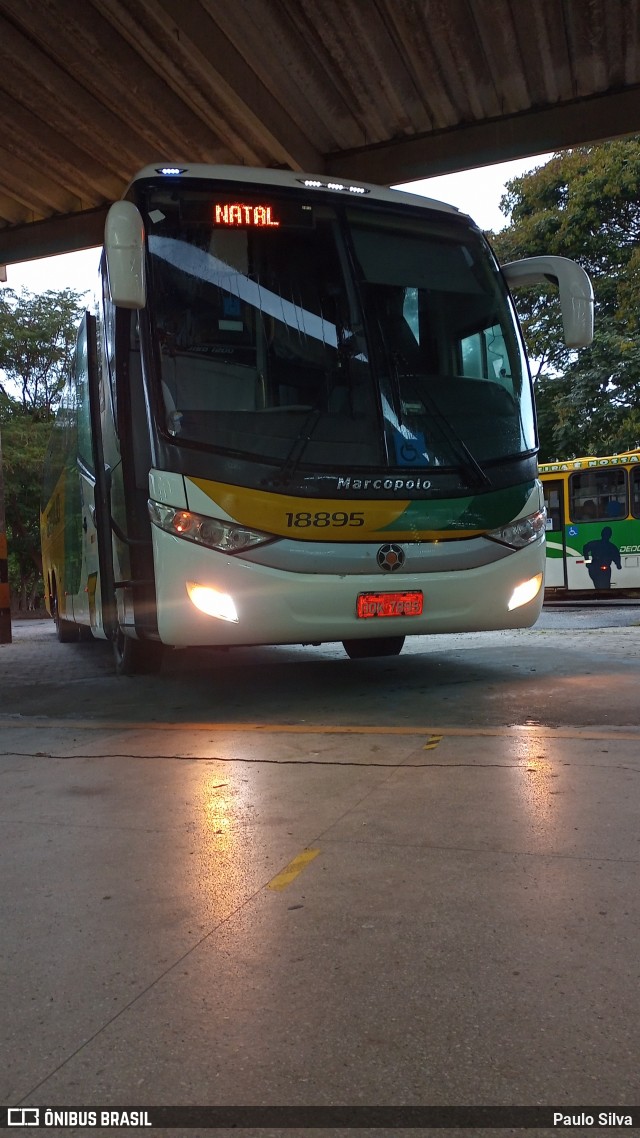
left=502, top=256, right=593, bottom=348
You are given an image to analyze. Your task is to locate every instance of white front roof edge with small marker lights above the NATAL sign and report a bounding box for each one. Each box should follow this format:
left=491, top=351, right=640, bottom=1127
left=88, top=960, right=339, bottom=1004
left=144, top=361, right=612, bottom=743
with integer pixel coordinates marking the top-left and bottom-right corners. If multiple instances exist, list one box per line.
left=124, top=163, right=466, bottom=225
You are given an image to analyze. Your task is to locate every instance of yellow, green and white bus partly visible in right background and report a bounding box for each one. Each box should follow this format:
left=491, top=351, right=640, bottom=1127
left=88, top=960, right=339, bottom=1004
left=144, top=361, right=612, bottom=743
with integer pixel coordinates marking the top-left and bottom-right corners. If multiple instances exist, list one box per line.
left=540, top=451, right=640, bottom=600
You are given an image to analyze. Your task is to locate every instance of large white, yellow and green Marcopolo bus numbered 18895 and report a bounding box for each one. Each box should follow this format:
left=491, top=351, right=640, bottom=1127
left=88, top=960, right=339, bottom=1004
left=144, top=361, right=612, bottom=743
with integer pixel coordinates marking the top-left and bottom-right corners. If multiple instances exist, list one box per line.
left=41, top=165, right=593, bottom=674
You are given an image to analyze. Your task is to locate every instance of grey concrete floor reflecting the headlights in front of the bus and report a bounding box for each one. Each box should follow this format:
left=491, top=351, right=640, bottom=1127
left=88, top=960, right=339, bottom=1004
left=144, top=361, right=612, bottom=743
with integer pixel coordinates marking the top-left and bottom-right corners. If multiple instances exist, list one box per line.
left=0, top=608, right=640, bottom=1138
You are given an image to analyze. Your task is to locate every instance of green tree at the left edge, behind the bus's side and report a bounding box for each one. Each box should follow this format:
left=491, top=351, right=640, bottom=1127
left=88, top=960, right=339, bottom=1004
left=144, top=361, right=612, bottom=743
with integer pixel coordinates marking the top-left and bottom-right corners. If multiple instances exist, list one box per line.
left=0, top=289, right=83, bottom=608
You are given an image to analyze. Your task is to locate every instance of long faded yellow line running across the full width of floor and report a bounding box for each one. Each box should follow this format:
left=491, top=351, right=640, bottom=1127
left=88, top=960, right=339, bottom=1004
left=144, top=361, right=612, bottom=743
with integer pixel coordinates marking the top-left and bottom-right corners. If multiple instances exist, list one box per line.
left=0, top=716, right=640, bottom=741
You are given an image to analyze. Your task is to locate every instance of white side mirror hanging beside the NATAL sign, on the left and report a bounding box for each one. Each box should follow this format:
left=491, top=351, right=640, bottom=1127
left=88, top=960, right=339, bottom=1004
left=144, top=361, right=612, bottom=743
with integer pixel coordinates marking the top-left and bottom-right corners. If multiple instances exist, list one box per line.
left=105, top=201, right=147, bottom=308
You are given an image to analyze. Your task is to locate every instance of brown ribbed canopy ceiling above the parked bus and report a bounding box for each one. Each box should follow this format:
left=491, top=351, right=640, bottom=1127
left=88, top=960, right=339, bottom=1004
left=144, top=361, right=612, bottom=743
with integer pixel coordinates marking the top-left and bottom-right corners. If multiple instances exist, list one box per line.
left=0, top=0, right=640, bottom=263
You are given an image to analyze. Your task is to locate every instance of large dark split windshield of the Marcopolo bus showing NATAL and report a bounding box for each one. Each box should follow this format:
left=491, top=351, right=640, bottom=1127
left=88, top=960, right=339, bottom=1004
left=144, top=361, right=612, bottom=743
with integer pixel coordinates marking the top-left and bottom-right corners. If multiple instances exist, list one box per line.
left=143, top=188, right=535, bottom=471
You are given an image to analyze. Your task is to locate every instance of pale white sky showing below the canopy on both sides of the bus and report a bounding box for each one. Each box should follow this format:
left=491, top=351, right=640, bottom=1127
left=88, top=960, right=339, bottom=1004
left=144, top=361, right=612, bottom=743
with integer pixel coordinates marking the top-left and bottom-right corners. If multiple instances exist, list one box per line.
left=0, top=154, right=551, bottom=292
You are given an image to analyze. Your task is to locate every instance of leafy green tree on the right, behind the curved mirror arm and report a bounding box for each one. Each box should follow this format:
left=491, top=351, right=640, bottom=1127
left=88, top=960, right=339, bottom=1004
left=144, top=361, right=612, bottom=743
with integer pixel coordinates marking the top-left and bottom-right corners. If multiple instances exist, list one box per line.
left=491, top=139, right=640, bottom=461
